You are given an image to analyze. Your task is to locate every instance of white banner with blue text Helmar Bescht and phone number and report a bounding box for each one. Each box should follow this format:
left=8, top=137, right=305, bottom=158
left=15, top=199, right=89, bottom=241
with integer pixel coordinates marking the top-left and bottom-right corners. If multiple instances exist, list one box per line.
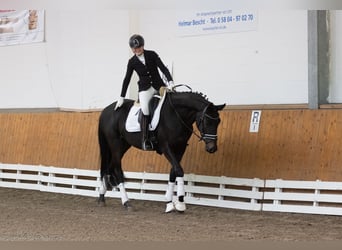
left=177, top=10, right=258, bottom=36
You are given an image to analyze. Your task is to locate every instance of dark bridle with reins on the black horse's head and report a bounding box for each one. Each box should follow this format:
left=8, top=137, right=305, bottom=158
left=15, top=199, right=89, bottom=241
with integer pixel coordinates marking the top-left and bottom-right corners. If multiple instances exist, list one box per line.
left=168, top=89, right=219, bottom=141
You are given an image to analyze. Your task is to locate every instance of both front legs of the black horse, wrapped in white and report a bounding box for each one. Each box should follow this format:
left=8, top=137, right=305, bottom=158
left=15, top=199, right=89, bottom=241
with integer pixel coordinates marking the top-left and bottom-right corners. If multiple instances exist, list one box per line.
left=165, top=146, right=186, bottom=213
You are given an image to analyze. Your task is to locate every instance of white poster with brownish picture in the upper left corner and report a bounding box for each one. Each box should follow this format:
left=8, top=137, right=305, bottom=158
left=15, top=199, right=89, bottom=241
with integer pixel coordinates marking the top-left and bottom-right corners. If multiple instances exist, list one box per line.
left=0, top=10, right=45, bottom=46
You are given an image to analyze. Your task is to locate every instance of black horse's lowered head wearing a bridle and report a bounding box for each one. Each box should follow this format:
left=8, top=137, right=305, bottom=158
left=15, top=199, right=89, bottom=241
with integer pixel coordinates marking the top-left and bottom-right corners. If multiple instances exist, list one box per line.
left=196, top=103, right=225, bottom=153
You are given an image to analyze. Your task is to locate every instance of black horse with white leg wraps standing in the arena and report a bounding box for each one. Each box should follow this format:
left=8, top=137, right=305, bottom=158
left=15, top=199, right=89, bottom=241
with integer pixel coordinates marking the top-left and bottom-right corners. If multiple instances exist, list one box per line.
left=98, top=88, right=225, bottom=212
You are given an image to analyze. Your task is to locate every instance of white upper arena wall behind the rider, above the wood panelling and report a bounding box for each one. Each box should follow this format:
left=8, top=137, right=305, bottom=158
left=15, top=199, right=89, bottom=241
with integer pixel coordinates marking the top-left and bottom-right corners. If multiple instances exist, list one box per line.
left=0, top=9, right=324, bottom=109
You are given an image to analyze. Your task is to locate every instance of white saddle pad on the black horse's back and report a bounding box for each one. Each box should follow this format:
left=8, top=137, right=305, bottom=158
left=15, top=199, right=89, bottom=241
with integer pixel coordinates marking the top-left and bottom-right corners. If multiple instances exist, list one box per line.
left=126, top=90, right=166, bottom=132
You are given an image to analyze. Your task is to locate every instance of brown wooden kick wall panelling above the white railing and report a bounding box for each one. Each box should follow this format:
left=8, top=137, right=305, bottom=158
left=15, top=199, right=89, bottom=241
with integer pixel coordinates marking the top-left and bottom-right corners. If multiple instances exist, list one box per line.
left=0, top=109, right=342, bottom=181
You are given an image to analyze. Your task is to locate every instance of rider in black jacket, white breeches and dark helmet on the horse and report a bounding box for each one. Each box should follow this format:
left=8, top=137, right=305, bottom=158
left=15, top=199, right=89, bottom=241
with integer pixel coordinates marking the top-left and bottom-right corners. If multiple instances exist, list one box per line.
left=114, top=34, right=174, bottom=150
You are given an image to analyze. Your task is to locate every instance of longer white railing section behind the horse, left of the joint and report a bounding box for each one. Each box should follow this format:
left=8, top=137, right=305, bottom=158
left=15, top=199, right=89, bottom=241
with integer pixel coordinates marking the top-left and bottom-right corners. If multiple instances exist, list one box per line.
left=0, top=164, right=264, bottom=210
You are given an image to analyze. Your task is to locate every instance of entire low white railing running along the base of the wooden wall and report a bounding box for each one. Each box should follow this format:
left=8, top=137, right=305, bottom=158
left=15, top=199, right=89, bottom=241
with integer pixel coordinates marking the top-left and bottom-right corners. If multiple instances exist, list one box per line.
left=0, top=163, right=342, bottom=215
